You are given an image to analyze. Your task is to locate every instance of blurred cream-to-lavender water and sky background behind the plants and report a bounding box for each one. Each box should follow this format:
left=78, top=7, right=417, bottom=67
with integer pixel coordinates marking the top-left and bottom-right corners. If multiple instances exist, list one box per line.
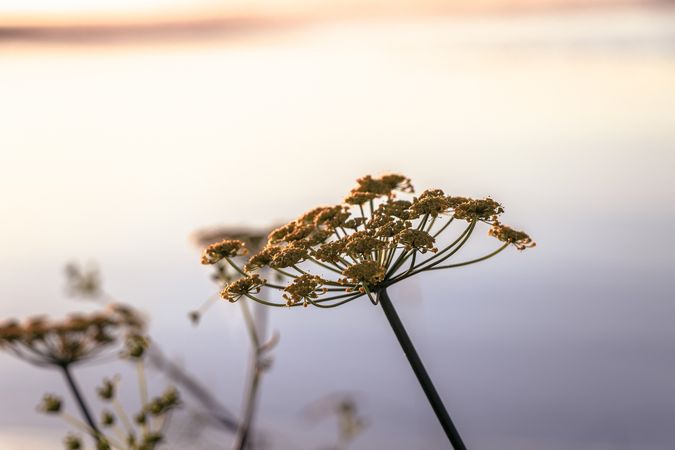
left=0, top=0, right=675, bottom=450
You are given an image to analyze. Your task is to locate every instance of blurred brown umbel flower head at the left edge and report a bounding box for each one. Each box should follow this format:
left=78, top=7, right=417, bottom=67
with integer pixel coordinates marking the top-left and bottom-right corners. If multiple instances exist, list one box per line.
left=0, top=304, right=144, bottom=366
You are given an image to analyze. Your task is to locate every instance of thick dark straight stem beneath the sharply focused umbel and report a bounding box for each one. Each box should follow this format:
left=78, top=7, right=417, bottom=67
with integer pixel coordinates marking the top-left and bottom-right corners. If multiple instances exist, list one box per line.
left=377, top=289, right=466, bottom=450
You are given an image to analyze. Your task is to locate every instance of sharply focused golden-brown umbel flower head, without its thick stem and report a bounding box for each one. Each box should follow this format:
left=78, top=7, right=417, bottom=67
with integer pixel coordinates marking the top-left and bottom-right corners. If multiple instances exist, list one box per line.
left=202, top=174, right=535, bottom=308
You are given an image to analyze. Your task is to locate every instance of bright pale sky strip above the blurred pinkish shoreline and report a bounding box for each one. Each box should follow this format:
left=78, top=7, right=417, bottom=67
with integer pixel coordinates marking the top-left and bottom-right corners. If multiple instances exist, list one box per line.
left=0, top=0, right=616, bottom=27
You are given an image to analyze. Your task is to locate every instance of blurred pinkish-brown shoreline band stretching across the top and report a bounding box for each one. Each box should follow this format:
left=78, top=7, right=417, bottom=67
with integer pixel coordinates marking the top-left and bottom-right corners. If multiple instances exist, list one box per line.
left=0, top=0, right=675, bottom=45
